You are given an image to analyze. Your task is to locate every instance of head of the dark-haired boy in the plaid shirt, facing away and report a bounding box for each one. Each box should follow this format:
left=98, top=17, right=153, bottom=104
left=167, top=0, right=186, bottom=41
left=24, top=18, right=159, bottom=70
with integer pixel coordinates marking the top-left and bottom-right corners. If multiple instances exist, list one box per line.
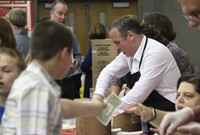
left=31, top=20, right=73, bottom=79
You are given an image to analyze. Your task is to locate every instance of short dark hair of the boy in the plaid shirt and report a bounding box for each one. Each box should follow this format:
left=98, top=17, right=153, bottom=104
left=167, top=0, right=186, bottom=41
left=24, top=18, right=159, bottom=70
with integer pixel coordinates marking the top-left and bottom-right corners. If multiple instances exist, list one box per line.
left=31, top=20, right=73, bottom=61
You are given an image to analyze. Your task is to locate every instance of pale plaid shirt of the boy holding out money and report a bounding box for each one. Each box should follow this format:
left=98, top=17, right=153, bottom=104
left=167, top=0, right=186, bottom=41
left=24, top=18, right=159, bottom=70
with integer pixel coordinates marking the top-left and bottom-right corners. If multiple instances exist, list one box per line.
left=0, top=62, right=62, bottom=135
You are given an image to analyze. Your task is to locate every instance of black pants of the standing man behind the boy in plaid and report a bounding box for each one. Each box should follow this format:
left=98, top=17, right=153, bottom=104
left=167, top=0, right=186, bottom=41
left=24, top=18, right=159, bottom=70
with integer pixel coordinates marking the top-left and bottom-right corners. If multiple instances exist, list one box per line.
left=56, top=74, right=81, bottom=99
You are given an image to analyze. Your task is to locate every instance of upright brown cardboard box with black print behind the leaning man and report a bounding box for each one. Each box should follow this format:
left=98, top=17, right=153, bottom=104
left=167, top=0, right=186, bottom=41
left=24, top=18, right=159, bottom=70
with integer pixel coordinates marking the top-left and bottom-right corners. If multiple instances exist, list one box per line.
left=91, top=39, right=118, bottom=88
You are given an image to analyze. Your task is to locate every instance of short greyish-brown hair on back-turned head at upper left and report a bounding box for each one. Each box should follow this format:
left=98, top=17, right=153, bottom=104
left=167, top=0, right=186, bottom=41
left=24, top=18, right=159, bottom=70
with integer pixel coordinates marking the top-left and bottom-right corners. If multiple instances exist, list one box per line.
left=8, top=8, right=27, bottom=28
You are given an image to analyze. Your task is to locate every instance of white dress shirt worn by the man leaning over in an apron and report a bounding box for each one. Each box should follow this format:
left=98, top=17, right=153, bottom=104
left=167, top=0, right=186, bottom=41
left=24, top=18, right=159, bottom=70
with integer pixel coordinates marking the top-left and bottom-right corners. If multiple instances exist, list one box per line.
left=94, top=36, right=181, bottom=113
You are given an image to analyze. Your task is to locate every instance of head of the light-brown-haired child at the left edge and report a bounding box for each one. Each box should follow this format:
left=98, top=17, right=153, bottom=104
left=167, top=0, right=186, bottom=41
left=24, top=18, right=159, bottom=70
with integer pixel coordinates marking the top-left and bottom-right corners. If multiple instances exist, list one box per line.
left=0, top=47, right=26, bottom=95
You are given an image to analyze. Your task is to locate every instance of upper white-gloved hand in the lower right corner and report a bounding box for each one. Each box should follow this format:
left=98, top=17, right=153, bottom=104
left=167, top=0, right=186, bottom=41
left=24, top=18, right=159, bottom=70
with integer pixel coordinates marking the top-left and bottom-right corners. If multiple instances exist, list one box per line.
left=159, top=107, right=194, bottom=135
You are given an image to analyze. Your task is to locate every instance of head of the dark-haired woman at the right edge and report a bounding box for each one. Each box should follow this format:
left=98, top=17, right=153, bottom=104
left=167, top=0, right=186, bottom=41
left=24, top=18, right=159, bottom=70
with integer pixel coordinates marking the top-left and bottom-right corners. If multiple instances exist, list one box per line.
left=176, top=75, right=200, bottom=110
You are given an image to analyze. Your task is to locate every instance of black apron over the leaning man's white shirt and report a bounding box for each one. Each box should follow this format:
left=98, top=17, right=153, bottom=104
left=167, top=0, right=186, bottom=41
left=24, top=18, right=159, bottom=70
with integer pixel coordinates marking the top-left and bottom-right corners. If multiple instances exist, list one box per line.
left=126, top=38, right=175, bottom=135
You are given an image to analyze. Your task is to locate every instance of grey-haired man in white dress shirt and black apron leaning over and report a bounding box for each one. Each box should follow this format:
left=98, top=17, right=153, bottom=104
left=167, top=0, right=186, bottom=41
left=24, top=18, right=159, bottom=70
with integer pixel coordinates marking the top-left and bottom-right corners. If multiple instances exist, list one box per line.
left=92, top=15, right=180, bottom=133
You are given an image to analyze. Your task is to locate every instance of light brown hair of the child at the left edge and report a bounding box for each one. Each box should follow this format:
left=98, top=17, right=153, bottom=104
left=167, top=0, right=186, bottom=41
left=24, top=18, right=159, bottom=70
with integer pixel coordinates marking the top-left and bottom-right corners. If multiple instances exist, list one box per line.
left=0, top=47, right=26, bottom=71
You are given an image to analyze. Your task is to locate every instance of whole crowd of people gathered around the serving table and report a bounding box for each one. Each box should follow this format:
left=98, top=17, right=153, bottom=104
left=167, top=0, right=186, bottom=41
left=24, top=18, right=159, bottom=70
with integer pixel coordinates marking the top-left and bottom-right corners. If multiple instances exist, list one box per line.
left=0, top=0, right=200, bottom=135
